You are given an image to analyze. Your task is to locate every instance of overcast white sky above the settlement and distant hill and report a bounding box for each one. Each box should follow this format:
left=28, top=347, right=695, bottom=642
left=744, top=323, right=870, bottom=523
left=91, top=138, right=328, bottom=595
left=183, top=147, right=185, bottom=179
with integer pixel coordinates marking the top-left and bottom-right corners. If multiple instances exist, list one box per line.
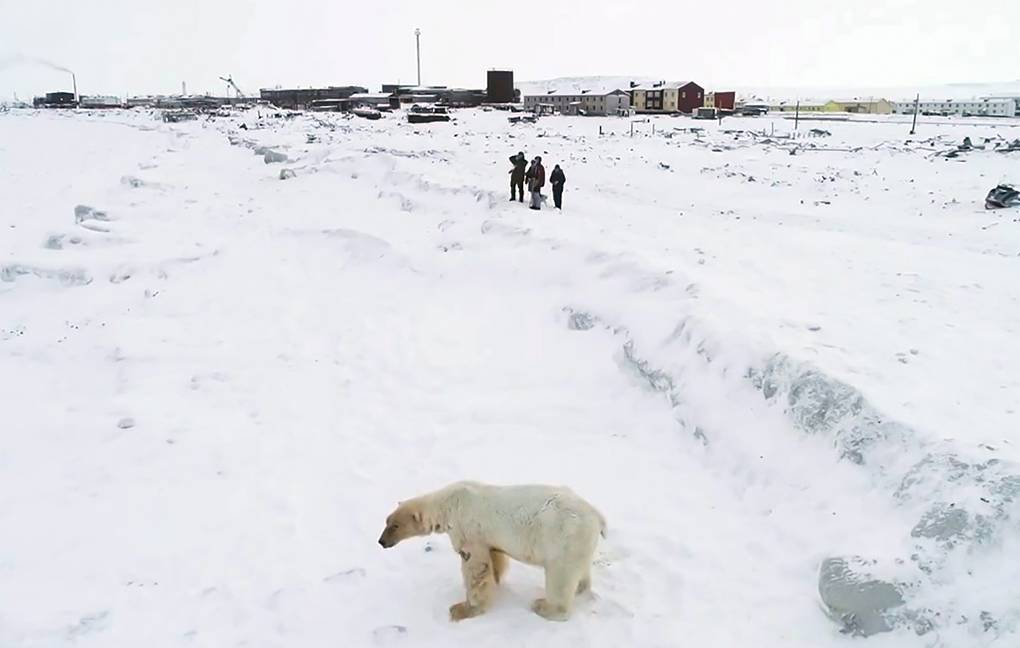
left=0, top=0, right=1020, bottom=98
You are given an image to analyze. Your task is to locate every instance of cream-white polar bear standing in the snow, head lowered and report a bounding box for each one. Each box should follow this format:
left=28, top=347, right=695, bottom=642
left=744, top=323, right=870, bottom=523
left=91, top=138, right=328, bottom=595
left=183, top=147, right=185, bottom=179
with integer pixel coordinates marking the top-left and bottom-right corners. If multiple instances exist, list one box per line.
left=379, top=482, right=606, bottom=621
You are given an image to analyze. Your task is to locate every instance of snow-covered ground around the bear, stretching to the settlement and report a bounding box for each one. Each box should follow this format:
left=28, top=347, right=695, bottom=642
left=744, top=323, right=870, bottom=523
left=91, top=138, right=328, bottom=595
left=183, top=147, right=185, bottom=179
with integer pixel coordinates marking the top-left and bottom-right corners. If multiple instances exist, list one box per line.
left=0, top=110, right=1020, bottom=648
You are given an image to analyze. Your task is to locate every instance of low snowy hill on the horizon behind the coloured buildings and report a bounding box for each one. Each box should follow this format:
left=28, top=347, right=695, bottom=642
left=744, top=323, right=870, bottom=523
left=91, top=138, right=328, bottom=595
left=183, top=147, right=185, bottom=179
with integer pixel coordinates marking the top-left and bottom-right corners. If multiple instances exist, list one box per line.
left=517, top=76, right=1020, bottom=101
